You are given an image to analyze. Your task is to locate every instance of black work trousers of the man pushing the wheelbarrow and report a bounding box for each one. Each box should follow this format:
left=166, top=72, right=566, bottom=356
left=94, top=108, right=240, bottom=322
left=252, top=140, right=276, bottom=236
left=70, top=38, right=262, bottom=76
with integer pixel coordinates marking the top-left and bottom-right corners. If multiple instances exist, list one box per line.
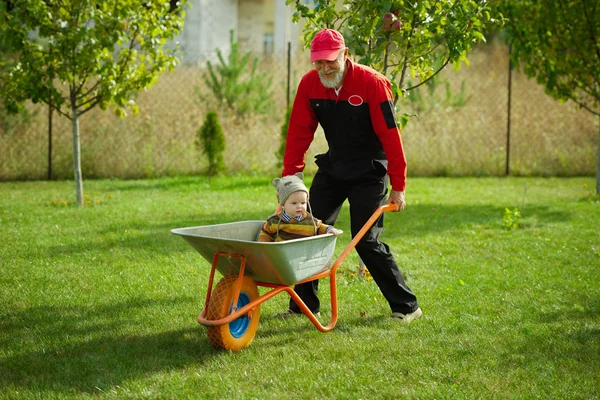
left=290, top=170, right=418, bottom=314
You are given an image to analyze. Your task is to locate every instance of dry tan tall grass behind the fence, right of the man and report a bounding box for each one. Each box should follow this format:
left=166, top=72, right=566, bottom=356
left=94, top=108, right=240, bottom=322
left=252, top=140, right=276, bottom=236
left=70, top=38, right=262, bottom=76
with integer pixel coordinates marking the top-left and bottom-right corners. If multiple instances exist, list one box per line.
left=403, top=43, right=599, bottom=176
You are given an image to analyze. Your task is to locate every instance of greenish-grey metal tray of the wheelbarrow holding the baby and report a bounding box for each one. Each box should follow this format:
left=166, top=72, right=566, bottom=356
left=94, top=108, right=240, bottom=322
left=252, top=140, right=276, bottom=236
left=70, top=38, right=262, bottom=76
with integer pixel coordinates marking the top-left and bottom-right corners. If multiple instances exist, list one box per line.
left=171, top=221, right=337, bottom=285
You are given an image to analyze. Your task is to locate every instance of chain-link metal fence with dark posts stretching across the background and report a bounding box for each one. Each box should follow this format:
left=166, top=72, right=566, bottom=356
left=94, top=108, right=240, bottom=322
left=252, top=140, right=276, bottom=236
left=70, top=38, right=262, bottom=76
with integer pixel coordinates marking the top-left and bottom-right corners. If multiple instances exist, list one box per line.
left=0, top=42, right=599, bottom=181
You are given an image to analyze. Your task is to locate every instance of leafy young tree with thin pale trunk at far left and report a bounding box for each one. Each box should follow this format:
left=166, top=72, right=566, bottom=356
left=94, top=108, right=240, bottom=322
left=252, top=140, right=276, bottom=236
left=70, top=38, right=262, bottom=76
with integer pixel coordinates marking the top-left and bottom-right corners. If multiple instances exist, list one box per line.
left=0, top=0, right=187, bottom=206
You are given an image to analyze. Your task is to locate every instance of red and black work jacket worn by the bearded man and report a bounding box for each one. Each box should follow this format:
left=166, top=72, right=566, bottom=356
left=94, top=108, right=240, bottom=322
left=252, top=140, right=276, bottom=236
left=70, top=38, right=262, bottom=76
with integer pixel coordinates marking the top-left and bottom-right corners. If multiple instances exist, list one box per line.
left=282, top=59, right=406, bottom=190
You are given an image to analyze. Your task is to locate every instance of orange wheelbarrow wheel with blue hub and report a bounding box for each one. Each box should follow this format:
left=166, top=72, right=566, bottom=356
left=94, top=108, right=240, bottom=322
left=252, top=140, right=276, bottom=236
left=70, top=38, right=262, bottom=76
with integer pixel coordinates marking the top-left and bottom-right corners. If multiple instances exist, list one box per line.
left=206, top=275, right=260, bottom=350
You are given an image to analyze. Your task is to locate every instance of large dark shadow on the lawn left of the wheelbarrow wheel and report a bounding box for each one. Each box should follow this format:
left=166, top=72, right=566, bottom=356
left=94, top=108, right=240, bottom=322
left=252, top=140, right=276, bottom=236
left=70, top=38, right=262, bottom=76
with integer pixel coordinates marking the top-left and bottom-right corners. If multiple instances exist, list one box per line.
left=0, top=297, right=217, bottom=394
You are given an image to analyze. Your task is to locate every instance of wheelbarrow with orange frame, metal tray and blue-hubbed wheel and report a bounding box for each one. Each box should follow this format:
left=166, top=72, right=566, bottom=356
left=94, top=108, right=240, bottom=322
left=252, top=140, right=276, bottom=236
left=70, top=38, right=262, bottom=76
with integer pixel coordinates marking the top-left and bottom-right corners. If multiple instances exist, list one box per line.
left=171, top=204, right=398, bottom=351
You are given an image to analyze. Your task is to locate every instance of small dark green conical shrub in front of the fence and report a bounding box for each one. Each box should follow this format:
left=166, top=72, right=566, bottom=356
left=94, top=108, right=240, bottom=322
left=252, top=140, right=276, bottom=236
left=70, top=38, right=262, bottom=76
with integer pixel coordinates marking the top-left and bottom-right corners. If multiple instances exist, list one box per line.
left=196, top=111, right=225, bottom=176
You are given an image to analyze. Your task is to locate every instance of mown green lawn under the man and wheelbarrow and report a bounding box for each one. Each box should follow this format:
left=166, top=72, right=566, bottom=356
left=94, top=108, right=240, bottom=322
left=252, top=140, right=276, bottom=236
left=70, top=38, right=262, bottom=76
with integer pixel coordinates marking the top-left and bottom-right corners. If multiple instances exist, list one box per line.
left=0, top=176, right=600, bottom=399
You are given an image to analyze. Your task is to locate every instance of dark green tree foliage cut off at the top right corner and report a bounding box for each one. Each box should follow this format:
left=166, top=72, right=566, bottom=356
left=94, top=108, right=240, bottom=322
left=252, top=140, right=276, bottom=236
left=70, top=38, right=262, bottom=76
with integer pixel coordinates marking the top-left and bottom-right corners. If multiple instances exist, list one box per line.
left=497, top=0, right=600, bottom=194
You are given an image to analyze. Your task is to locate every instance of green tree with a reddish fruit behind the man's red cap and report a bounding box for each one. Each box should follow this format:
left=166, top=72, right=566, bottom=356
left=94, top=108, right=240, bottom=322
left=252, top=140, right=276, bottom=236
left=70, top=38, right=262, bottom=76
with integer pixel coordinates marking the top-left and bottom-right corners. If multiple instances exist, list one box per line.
left=287, top=0, right=500, bottom=126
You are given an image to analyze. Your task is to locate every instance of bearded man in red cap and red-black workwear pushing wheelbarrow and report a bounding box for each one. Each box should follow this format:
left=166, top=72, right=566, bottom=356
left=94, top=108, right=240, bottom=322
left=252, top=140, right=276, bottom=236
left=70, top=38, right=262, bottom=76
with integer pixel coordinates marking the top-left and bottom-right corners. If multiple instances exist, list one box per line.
left=278, top=29, right=422, bottom=323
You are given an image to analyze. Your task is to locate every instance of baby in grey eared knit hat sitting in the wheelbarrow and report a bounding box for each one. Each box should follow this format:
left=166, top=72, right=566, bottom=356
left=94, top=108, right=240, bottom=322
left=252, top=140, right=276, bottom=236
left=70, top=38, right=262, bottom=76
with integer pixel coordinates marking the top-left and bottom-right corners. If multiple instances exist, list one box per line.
left=258, top=172, right=342, bottom=242
